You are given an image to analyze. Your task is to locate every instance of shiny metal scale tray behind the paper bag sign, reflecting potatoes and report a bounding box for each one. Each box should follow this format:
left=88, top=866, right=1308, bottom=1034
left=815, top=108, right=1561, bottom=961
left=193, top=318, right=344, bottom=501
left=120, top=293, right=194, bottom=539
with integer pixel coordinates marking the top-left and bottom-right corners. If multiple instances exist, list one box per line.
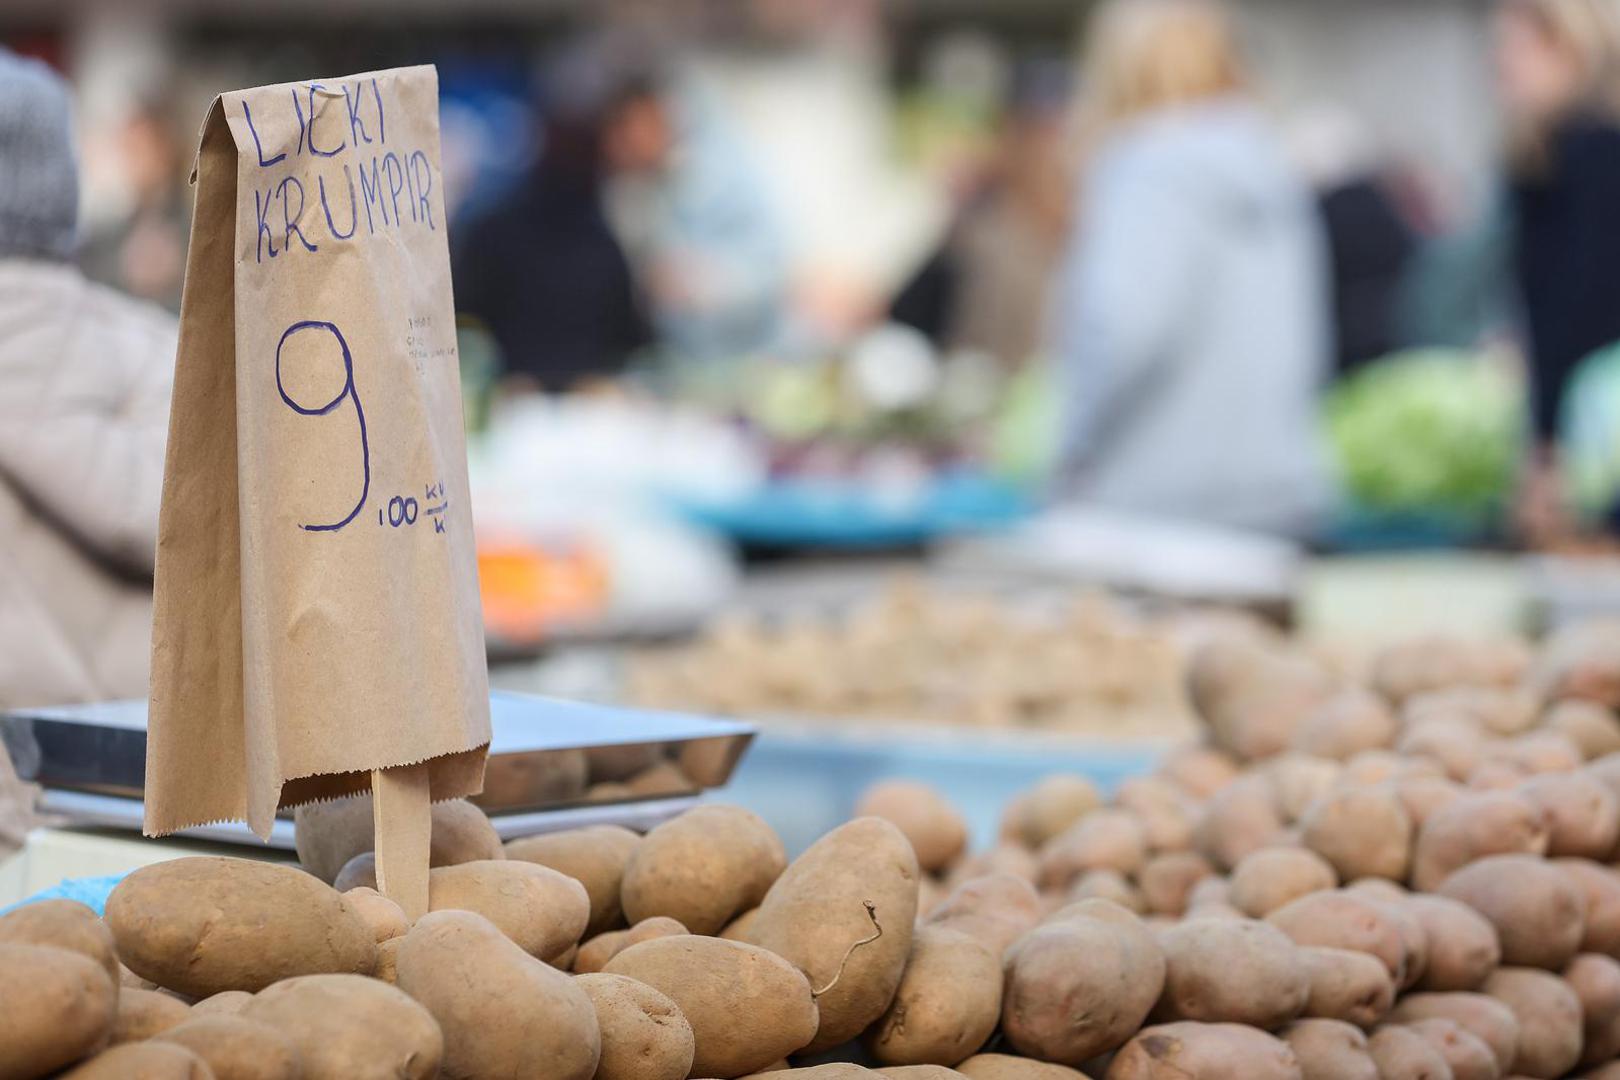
left=0, top=690, right=755, bottom=848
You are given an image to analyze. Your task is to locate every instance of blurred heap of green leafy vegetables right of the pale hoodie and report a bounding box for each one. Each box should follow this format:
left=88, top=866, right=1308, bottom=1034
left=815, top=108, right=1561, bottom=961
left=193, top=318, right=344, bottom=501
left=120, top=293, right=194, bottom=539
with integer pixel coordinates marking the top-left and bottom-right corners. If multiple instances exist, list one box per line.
left=1325, top=350, right=1523, bottom=528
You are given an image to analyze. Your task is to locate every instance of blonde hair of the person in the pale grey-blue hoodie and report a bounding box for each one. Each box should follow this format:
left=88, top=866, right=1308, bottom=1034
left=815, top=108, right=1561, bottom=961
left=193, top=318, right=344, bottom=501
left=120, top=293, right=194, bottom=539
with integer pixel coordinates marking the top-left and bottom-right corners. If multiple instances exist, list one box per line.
left=1079, top=0, right=1247, bottom=139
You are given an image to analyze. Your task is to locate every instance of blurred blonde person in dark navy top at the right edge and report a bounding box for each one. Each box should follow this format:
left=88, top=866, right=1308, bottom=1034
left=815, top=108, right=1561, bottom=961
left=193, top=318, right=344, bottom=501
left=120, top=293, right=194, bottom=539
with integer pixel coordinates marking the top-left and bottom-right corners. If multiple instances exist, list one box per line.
left=1495, top=0, right=1620, bottom=542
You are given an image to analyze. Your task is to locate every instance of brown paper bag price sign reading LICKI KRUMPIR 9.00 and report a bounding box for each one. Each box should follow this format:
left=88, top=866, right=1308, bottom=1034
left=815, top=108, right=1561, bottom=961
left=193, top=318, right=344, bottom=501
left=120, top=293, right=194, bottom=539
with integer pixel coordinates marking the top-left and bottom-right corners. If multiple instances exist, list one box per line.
left=146, top=66, right=489, bottom=837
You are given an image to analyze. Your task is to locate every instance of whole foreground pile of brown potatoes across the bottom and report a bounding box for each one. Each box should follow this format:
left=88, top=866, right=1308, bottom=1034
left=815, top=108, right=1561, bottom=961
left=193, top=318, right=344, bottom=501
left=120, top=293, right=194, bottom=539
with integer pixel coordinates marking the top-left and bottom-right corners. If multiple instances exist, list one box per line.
left=9, top=615, right=1620, bottom=1080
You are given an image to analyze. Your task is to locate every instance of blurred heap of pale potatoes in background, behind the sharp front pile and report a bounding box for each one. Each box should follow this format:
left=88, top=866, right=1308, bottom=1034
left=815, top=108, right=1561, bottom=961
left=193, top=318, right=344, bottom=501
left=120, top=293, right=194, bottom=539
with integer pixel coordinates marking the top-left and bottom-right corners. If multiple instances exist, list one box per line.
left=625, top=583, right=1191, bottom=738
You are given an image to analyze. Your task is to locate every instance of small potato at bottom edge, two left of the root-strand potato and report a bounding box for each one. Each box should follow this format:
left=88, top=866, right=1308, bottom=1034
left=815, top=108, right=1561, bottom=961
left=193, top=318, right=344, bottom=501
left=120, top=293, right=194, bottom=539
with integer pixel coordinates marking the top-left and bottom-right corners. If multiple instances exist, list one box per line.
left=575, top=975, right=695, bottom=1080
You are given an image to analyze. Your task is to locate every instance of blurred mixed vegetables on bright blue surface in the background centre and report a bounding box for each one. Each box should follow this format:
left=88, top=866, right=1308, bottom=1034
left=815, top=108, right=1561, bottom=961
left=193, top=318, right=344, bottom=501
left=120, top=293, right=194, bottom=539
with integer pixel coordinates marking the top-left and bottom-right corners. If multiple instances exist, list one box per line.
left=661, top=324, right=1051, bottom=547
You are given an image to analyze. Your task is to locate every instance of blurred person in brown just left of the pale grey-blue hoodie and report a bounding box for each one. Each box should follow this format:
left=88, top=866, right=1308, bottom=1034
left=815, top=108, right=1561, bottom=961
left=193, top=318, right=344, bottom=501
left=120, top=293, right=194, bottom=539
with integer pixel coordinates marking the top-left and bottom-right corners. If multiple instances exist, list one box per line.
left=889, top=62, right=1069, bottom=366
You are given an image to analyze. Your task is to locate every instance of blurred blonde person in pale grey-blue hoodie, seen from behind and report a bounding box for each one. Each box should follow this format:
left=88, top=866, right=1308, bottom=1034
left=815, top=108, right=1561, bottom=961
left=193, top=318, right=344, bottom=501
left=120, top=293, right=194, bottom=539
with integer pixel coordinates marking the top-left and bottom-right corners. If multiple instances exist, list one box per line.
left=1053, top=0, right=1332, bottom=536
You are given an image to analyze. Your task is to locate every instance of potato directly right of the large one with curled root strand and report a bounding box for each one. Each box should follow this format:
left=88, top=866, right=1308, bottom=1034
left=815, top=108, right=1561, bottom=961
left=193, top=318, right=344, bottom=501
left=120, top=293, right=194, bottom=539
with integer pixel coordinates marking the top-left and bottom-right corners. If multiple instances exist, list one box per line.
left=867, top=925, right=1014, bottom=1065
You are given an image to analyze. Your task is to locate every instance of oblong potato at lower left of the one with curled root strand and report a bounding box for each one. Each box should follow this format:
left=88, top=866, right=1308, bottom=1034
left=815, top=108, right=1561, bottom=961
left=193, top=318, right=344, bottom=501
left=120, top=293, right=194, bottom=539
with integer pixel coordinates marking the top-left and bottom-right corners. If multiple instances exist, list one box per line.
left=606, top=932, right=816, bottom=1077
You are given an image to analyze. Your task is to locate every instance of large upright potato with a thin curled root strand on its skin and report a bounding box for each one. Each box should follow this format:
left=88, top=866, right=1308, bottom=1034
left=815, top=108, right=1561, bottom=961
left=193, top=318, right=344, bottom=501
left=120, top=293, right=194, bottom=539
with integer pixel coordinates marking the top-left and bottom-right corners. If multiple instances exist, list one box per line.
left=748, top=818, right=919, bottom=1054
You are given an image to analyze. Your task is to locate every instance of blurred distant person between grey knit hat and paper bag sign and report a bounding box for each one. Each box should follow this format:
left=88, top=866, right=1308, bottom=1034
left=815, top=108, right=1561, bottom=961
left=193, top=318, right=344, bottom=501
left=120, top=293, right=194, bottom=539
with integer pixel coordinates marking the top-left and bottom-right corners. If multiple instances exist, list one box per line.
left=79, top=99, right=191, bottom=311
